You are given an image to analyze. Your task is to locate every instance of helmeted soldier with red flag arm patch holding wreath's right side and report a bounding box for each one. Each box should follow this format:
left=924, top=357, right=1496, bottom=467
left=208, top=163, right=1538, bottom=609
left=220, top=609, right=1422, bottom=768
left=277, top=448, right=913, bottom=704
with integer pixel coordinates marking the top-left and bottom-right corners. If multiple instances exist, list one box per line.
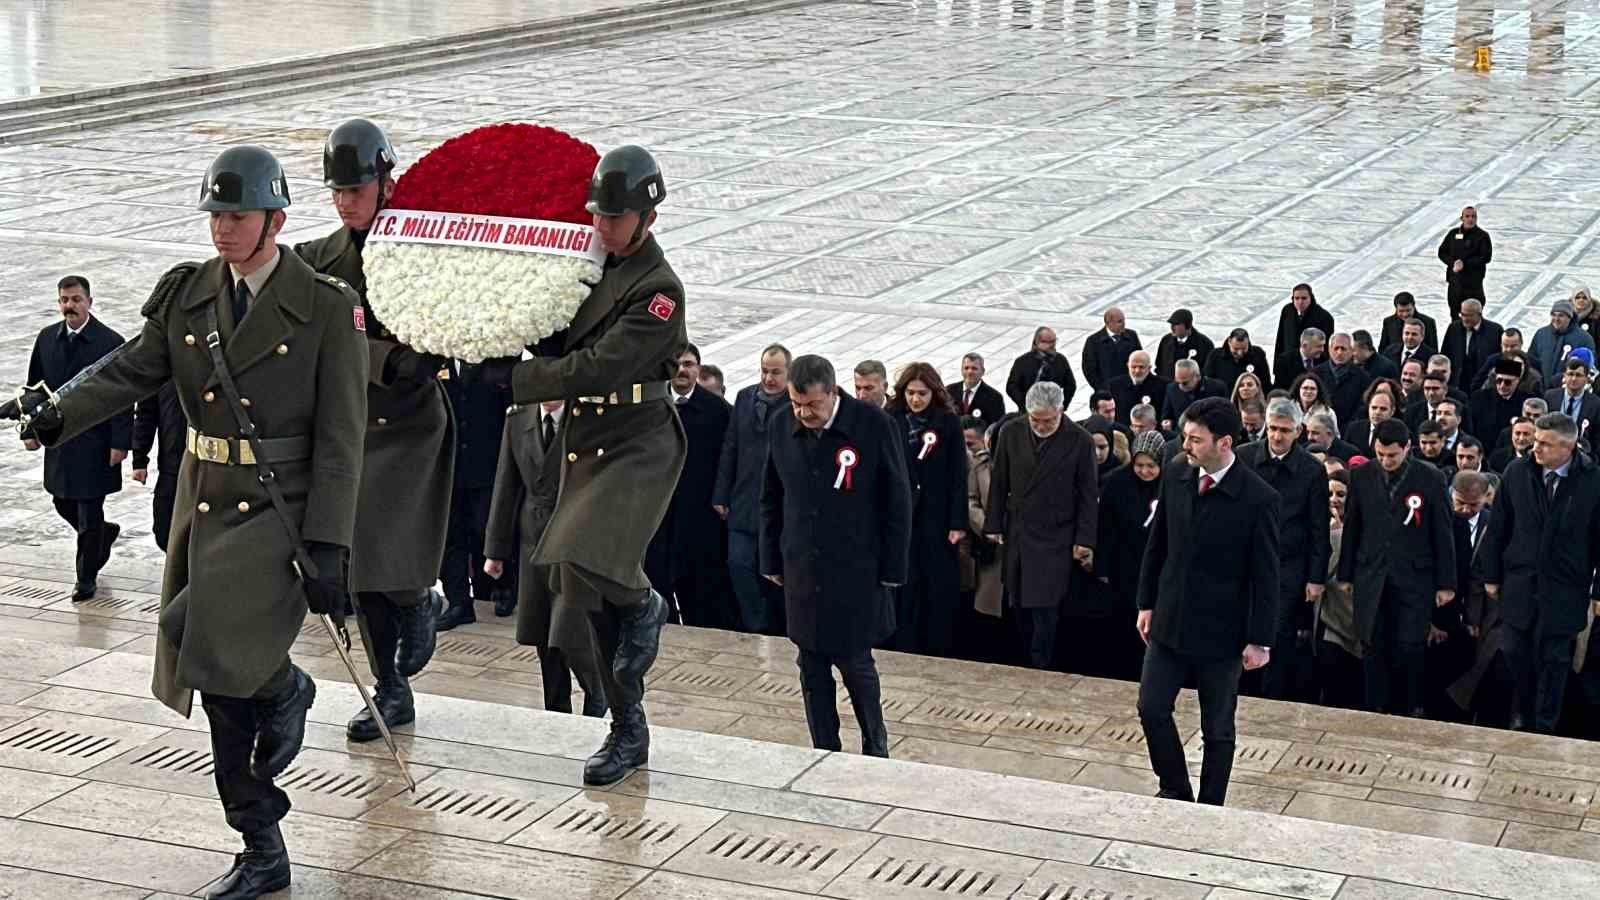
left=485, top=146, right=688, bottom=785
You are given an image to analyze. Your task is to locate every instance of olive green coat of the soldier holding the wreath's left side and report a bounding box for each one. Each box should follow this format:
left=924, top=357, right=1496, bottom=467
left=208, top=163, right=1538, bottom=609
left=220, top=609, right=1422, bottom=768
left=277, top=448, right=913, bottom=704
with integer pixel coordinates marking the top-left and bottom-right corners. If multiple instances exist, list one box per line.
left=294, top=227, right=456, bottom=591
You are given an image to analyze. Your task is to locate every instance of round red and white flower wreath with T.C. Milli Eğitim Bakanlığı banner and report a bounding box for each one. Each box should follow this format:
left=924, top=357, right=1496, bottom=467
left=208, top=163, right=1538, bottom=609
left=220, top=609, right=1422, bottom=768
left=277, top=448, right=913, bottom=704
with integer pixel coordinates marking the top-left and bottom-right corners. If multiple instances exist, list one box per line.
left=362, top=125, right=605, bottom=362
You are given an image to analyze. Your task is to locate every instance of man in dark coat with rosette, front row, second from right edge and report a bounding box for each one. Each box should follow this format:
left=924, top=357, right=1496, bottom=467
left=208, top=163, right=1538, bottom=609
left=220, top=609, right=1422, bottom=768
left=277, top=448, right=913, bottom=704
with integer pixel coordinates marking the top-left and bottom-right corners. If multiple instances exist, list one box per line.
left=1339, top=420, right=1456, bottom=716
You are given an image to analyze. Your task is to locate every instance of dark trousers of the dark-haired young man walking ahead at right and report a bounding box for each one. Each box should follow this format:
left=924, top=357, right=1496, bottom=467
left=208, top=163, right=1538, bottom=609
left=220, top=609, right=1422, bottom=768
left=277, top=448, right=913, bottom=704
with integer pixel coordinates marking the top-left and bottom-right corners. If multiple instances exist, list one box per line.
left=1139, top=641, right=1243, bottom=806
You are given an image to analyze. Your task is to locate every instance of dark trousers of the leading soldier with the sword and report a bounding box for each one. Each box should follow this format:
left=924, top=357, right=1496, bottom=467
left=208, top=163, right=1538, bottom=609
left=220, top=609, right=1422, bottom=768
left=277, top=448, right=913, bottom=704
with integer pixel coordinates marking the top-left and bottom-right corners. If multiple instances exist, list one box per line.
left=200, top=657, right=294, bottom=834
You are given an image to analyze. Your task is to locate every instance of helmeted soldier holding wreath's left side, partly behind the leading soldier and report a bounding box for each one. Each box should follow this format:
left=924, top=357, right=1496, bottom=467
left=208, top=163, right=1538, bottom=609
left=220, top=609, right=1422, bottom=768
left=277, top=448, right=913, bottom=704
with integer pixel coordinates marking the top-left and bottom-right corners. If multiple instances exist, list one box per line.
left=294, top=119, right=456, bottom=741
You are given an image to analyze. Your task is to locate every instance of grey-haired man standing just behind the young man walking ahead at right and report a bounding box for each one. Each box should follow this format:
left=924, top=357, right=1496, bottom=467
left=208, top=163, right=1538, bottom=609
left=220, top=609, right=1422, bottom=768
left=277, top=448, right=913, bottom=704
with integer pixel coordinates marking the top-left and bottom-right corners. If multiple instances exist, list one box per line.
left=1235, top=397, right=1338, bottom=701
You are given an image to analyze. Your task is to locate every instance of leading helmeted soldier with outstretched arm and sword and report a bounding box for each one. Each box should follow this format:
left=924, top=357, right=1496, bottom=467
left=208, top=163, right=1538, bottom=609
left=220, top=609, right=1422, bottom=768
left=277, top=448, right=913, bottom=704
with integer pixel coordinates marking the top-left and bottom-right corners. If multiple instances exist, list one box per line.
left=0, top=146, right=366, bottom=900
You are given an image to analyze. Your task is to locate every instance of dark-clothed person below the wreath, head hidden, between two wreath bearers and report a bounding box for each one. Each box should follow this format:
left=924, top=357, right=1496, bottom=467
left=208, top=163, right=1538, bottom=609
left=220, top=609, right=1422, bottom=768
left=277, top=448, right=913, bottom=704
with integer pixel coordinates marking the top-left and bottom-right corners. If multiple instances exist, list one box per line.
left=438, top=360, right=518, bottom=631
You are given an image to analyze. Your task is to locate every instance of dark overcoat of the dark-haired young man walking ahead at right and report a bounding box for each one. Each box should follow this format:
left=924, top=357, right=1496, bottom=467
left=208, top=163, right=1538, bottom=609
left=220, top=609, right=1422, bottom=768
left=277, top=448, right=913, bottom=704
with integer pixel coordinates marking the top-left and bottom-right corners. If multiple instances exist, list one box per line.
left=1139, top=458, right=1280, bottom=660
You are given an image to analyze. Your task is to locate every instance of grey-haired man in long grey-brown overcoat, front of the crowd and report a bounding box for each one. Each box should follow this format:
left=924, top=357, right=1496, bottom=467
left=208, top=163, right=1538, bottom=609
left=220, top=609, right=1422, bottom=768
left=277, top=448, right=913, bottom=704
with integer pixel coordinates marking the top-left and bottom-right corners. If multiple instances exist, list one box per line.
left=984, top=381, right=1099, bottom=669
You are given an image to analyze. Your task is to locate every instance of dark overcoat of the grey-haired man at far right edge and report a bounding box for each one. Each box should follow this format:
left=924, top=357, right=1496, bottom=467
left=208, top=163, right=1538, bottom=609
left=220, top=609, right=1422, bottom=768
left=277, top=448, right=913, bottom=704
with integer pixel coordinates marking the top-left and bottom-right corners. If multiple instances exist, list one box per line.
left=1478, top=453, right=1600, bottom=637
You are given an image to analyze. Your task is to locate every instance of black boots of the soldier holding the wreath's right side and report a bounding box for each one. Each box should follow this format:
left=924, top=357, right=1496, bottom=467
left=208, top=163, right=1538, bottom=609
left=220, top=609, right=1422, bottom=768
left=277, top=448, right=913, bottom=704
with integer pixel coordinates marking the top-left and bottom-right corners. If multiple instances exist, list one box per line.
left=584, top=591, right=667, bottom=786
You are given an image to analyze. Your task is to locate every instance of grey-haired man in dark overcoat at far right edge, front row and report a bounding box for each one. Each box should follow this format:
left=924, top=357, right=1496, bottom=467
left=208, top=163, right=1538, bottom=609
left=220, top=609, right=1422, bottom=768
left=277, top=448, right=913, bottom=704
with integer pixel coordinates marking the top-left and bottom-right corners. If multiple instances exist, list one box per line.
left=1483, top=413, right=1600, bottom=733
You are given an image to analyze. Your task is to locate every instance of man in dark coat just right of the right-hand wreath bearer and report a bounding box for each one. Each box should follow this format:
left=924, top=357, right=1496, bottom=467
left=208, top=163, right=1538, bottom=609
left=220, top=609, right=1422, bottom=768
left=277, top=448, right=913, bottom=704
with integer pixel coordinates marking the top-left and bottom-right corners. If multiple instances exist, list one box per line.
left=645, top=344, right=739, bottom=628
